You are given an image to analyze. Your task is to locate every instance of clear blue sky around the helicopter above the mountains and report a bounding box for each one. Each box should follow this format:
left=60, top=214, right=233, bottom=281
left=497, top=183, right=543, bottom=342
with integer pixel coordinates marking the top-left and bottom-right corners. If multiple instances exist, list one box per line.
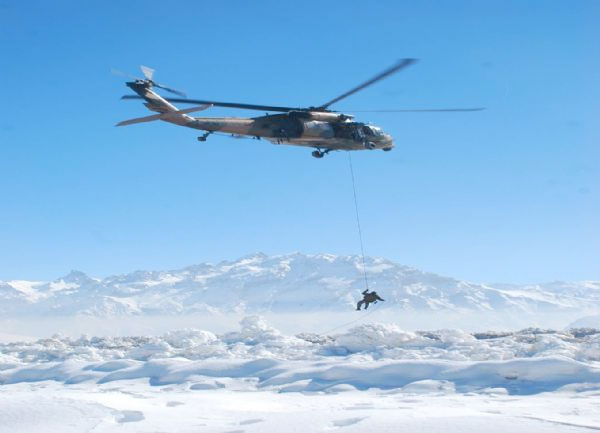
left=0, top=0, right=600, bottom=282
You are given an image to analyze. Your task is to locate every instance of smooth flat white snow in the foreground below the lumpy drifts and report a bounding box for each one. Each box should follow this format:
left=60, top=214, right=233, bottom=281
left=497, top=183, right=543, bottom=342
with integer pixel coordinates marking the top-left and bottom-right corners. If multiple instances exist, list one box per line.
left=0, top=380, right=600, bottom=433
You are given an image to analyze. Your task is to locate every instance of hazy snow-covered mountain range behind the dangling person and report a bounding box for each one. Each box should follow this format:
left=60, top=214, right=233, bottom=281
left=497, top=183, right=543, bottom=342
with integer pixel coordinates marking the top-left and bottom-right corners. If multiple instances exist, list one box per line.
left=0, top=253, right=600, bottom=317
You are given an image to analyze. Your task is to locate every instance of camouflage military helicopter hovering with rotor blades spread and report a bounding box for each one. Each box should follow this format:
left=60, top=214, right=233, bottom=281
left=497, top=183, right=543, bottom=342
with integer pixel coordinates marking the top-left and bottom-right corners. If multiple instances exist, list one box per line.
left=113, top=59, right=483, bottom=158
